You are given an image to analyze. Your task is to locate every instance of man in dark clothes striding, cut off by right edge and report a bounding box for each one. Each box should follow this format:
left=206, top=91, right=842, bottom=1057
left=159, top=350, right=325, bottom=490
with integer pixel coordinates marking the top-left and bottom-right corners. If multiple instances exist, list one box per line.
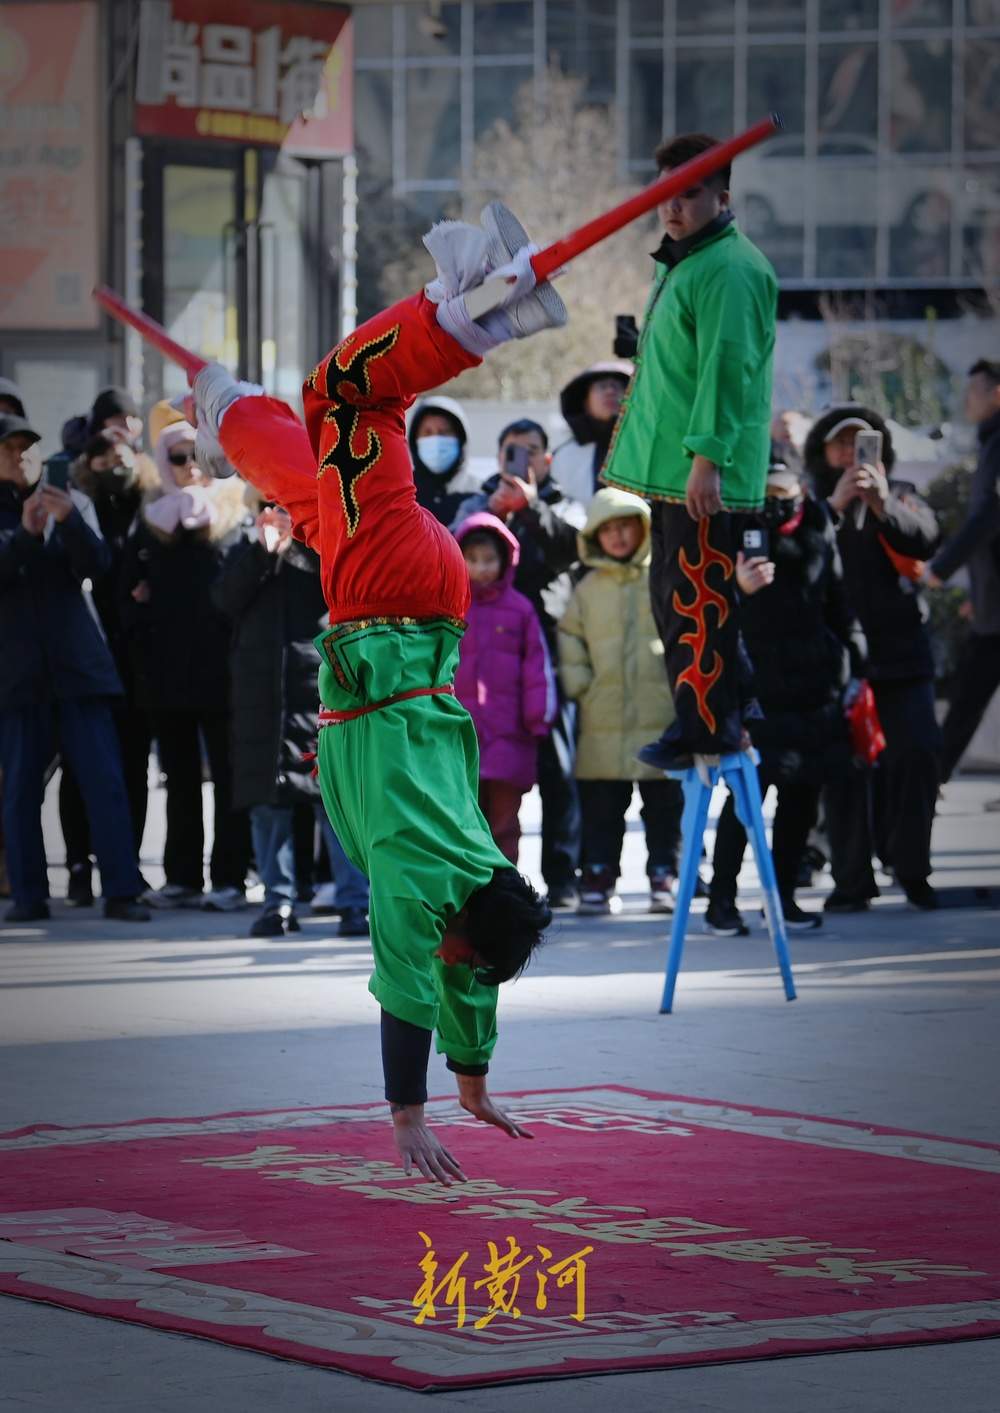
left=927, top=359, right=1000, bottom=780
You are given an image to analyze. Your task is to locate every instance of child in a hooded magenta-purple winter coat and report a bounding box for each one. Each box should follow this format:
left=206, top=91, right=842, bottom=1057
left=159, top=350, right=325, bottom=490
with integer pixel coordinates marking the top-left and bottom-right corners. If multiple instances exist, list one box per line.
left=455, top=512, right=556, bottom=865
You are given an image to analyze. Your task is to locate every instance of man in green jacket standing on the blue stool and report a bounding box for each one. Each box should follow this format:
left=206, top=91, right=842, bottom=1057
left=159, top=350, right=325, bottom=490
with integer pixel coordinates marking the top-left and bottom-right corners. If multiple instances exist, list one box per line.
left=602, top=134, right=777, bottom=770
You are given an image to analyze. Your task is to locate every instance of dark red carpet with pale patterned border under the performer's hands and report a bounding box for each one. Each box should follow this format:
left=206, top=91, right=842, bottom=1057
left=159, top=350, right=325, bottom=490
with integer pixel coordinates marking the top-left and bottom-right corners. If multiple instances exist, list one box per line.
left=0, top=1085, right=1000, bottom=1388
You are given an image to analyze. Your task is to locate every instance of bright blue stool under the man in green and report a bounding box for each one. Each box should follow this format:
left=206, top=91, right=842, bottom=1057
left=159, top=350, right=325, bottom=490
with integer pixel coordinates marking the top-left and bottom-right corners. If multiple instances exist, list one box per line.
left=660, top=750, right=795, bottom=1015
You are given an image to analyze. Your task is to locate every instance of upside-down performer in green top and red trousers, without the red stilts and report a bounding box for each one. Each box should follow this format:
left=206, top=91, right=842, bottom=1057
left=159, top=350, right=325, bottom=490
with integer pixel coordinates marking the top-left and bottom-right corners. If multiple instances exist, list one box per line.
left=194, top=202, right=566, bottom=1184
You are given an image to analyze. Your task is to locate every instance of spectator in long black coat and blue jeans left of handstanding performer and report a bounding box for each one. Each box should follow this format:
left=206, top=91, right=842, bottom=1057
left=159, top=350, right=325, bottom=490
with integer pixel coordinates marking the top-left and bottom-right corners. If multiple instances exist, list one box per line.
left=212, top=506, right=369, bottom=937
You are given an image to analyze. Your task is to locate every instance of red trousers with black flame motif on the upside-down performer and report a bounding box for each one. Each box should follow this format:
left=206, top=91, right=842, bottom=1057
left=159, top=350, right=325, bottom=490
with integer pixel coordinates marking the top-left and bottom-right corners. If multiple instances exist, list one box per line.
left=219, top=294, right=480, bottom=623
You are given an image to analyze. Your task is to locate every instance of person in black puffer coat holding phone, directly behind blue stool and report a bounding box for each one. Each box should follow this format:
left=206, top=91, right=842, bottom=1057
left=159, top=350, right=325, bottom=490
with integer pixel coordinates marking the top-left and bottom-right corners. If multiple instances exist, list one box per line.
left=705, top=459, right=864, bottom=935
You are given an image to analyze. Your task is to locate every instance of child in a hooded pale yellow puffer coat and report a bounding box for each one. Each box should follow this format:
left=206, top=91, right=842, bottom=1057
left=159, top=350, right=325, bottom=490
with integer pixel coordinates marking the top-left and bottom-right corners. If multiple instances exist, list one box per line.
left=559, top=486, right=684, bottom=913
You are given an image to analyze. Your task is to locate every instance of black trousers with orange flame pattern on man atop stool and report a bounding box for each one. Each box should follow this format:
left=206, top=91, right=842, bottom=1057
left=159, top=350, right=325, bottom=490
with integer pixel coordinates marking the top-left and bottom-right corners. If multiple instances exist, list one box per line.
left=650, top=500, right=743, bottom=755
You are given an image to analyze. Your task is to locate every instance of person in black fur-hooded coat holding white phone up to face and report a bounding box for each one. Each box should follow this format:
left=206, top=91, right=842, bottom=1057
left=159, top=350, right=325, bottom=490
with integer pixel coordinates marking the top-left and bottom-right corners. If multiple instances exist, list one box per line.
left=804, top=403, right=941, bottom=911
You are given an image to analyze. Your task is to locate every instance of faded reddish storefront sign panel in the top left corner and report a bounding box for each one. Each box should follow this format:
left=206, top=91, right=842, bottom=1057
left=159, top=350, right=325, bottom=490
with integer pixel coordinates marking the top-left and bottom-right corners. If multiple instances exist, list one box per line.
left=0, top=3, right=100, bottom=329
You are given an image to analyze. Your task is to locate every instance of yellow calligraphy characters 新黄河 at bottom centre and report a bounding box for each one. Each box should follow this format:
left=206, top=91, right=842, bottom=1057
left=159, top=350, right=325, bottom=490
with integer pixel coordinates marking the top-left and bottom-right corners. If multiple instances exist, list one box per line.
left=412, top=1232, right=593, bottom=1330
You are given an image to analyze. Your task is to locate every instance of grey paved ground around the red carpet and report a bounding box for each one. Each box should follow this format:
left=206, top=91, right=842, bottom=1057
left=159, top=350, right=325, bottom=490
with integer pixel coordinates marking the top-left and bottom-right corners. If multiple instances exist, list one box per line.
left=0, top=777, right=1000, bottom=1413
